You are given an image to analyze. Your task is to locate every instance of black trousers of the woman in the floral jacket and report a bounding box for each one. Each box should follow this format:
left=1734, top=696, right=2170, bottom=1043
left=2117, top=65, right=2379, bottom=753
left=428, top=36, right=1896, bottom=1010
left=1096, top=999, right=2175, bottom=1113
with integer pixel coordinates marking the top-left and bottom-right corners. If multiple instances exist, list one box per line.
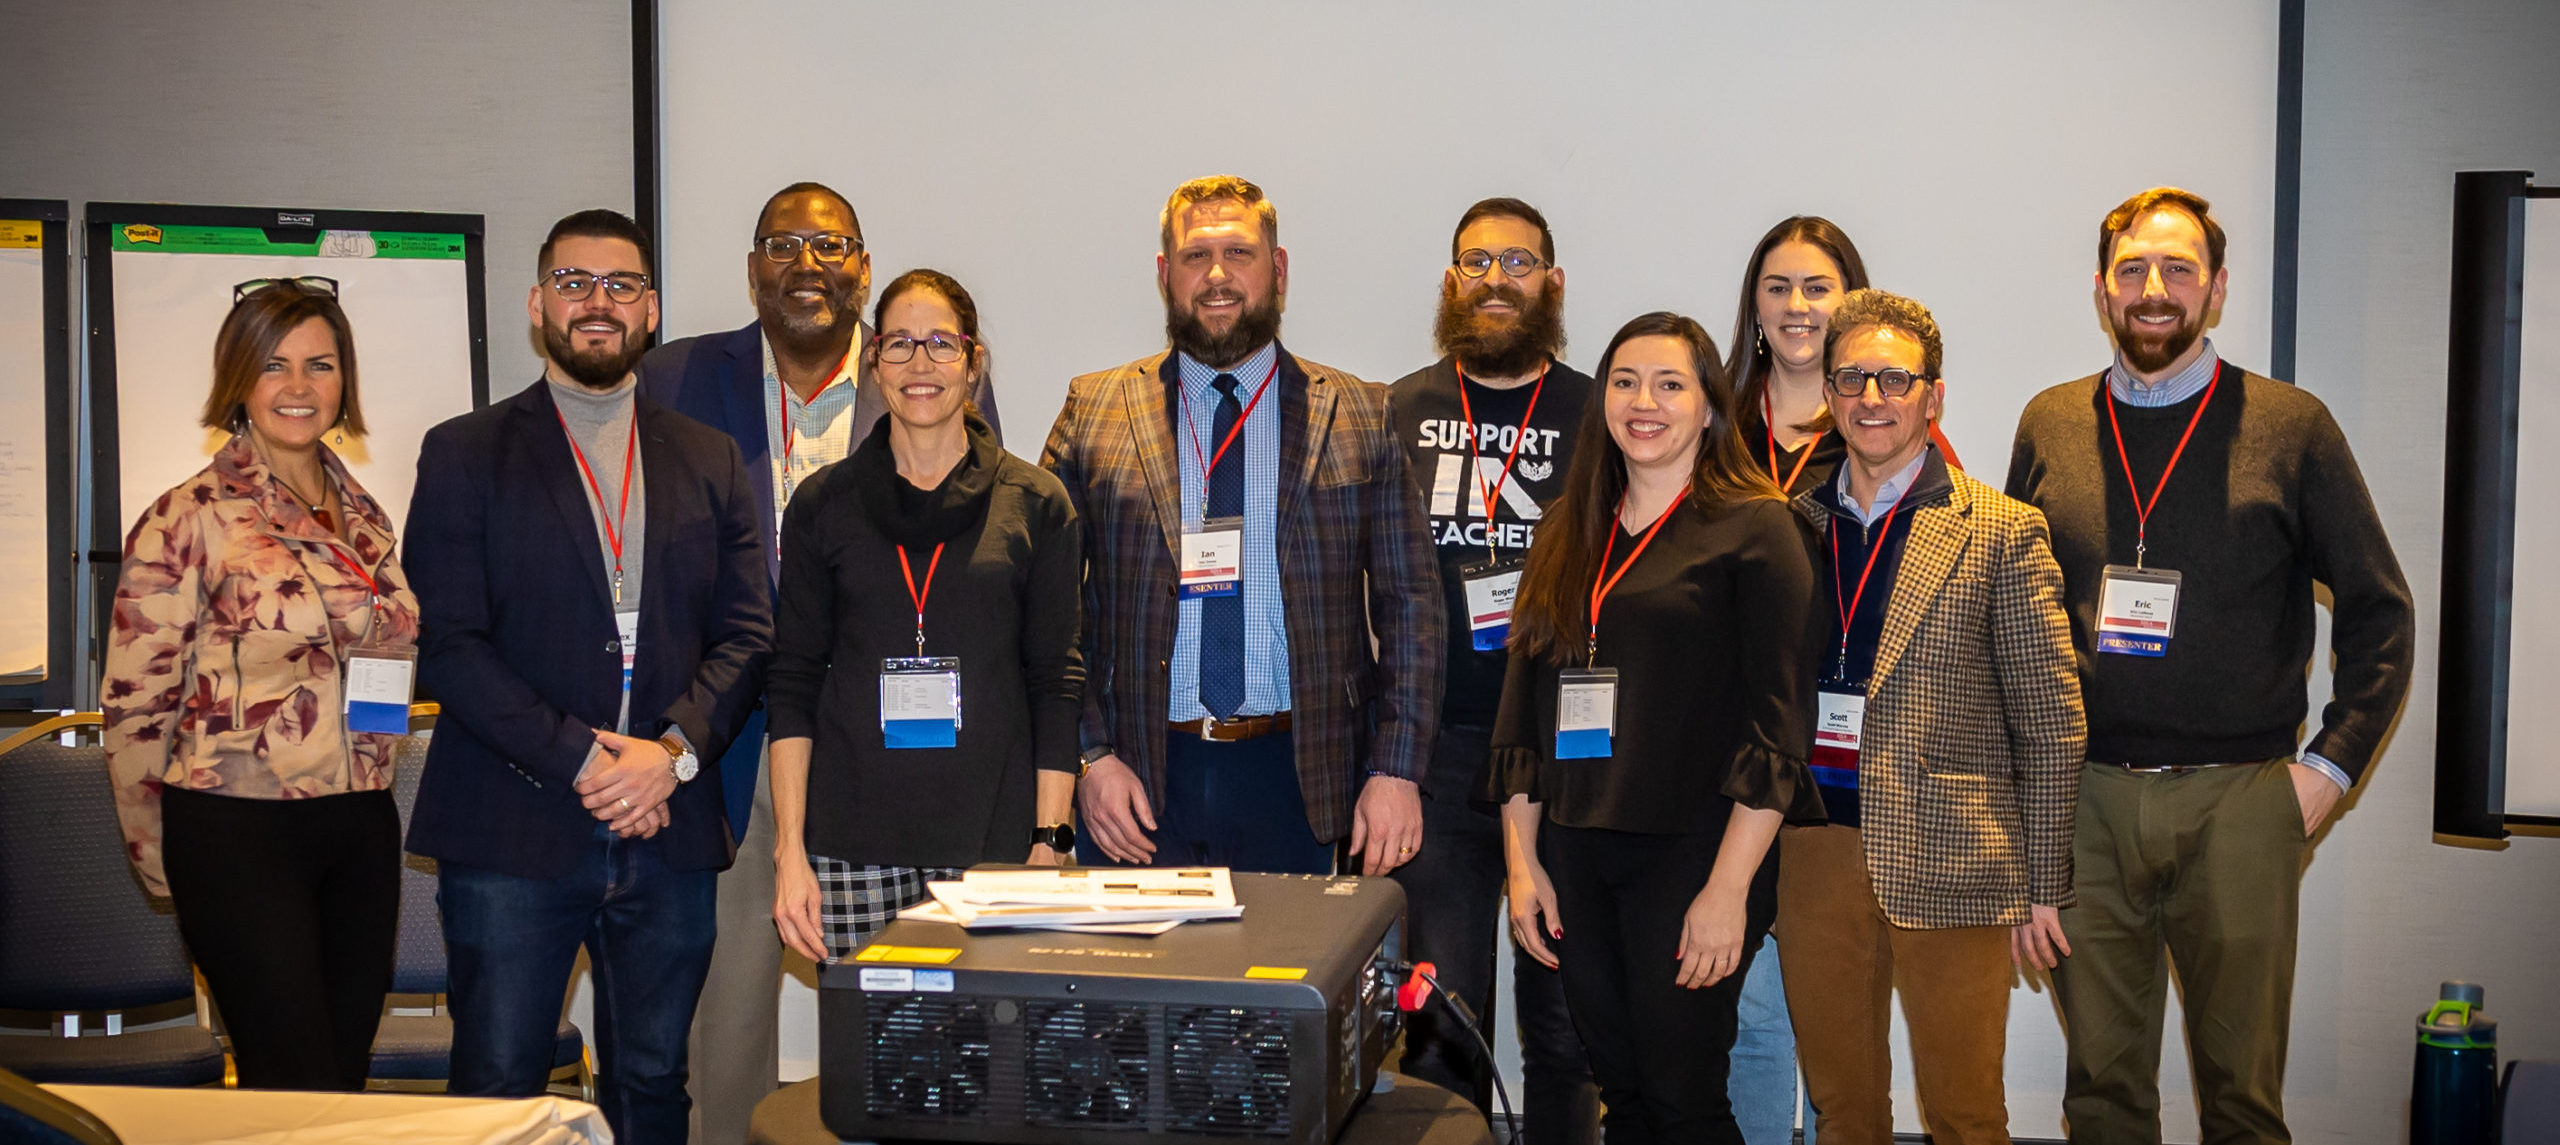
left=161, top=789, right=399, bottom=1091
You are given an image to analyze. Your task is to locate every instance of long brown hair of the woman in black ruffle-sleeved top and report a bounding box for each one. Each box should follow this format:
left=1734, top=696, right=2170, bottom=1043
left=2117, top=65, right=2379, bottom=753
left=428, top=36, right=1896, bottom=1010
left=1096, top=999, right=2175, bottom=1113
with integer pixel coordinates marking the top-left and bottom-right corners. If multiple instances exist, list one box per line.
left=1510, top=310, right=1779, bottom=663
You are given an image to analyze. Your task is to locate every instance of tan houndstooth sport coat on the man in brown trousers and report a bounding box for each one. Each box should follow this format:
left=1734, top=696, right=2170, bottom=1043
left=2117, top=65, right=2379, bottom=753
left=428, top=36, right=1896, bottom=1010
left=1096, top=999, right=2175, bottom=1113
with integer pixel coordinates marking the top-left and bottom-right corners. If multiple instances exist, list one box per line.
left=1795, top=469, right=2089, bottom=930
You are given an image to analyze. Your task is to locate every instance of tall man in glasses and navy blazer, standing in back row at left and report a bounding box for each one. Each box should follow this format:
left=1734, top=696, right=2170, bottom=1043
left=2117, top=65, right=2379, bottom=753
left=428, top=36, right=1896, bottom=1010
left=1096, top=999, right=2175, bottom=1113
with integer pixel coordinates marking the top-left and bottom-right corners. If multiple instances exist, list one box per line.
left=640, top=182, right=996, bottom=1142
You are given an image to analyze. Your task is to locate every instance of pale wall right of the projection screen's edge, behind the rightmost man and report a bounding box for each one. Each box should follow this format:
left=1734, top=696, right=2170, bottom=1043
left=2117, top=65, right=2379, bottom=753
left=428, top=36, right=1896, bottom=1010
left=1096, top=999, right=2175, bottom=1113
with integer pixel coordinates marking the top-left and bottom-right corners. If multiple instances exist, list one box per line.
left=2283, top=0, right=2560, bottom=1142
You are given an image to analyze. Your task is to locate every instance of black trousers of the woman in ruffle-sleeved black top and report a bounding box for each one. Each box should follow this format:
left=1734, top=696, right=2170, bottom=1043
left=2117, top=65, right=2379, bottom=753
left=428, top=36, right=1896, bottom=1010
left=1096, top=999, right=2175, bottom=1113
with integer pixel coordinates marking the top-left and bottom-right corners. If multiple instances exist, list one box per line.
left=1539, top=822, right=1777, bottom=1145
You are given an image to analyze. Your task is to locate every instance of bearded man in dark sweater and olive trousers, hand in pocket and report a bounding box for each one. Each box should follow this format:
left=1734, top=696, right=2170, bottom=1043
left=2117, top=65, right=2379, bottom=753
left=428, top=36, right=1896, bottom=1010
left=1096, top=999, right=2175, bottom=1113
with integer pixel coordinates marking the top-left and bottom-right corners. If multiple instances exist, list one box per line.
left=2007, top=187, right=2414, bottom=1142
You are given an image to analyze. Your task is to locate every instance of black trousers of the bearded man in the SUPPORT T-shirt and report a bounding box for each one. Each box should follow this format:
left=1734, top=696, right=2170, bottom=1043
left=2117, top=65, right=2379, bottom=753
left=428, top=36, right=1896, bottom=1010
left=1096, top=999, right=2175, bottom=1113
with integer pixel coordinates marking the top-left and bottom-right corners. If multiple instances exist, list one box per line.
left=1393, top=725, right=1600, bottom=1145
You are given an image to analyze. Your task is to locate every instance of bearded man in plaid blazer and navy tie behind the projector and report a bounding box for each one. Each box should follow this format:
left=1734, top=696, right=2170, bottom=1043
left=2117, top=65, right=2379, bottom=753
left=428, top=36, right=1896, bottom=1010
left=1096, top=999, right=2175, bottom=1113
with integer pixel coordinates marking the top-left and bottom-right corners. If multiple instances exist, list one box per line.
left=1042, top=177, right=1444, bottom=873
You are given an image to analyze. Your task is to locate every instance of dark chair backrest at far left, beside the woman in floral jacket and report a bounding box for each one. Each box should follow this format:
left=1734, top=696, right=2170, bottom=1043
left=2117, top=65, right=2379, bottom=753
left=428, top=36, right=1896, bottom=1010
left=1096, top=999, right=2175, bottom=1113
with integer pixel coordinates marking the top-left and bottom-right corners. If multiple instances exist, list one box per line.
left=0, top=740, right=195, bottom=1012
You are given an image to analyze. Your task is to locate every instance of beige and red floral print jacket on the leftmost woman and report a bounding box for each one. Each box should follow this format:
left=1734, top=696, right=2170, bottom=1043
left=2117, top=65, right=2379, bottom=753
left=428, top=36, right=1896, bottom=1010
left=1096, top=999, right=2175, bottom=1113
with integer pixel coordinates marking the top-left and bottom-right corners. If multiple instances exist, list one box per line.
left=100, top=435, right=417, bottom=894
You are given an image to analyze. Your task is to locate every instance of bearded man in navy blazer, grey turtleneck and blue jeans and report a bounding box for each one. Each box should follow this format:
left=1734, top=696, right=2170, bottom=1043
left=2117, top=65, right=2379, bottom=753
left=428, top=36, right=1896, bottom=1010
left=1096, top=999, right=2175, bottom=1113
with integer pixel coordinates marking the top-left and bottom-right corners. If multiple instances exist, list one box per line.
left=404, top=210, right=773, bottom=1142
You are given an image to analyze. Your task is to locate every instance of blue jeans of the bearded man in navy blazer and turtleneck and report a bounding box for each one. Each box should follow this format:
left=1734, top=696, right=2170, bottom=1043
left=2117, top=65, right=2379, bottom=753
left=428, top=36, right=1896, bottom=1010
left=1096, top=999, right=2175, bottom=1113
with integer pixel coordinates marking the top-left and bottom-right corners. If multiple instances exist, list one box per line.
left=435, top=822, right=717, bottom=1145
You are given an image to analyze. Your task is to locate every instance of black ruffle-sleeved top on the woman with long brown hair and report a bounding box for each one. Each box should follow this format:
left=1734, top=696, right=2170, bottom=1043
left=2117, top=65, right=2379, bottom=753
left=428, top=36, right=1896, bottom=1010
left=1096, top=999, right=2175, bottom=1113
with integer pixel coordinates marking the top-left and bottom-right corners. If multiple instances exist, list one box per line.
left=1485, top=494, right=1823, bottom=835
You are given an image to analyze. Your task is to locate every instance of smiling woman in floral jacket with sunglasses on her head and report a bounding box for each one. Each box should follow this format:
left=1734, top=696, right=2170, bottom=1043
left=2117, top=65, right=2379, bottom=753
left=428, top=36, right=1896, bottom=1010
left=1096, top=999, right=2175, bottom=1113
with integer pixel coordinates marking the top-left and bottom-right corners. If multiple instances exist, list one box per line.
left=102, top=277, right=417, bottom=1089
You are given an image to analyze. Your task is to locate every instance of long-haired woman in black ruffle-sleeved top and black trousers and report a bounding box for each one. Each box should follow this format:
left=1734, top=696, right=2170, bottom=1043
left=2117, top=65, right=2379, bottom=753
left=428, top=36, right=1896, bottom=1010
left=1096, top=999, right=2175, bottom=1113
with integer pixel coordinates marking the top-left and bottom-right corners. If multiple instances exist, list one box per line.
left=1490, top=313, right=1820, bottom=1142
